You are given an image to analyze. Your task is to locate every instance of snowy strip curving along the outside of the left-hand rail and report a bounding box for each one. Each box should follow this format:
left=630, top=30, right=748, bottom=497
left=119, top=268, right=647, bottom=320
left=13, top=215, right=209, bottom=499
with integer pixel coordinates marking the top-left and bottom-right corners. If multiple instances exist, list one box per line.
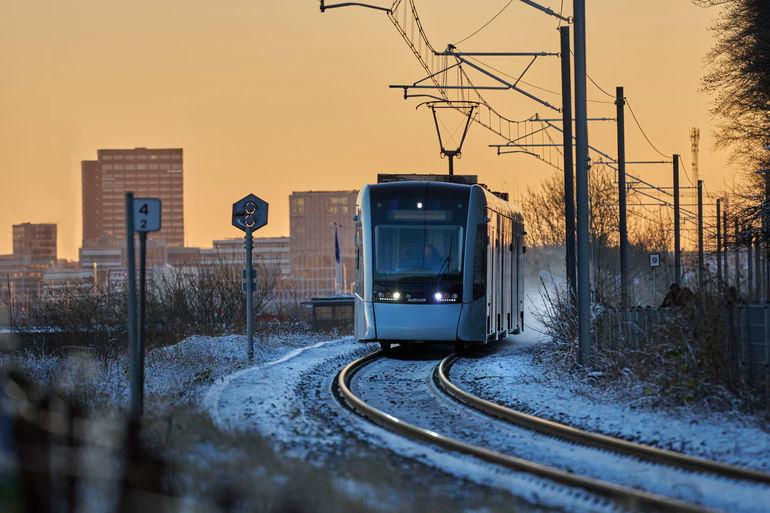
left=204, top=339, right=617, bottom=512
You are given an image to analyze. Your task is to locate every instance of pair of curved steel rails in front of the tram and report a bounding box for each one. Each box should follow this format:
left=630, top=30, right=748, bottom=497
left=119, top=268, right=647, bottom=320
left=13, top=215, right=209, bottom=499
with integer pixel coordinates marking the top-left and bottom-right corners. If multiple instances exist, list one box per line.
left=335, top=352, right=768, bottom=513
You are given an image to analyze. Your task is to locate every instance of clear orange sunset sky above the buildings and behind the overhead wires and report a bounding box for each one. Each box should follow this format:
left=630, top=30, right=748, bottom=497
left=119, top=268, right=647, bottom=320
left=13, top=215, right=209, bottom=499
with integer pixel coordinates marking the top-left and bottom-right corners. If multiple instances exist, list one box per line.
left=0, top=0, right=728, bottom=258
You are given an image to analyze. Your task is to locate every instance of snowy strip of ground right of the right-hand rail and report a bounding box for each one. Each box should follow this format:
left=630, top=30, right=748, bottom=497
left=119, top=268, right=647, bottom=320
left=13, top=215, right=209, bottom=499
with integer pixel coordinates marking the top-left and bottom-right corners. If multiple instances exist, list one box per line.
left=450, top=337, right=770, bottom=472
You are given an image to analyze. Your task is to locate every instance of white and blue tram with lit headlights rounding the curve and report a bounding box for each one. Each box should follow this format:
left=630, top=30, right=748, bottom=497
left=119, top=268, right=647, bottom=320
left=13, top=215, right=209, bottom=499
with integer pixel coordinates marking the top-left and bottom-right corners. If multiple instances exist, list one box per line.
left=355, top=181, right=525, bottom=349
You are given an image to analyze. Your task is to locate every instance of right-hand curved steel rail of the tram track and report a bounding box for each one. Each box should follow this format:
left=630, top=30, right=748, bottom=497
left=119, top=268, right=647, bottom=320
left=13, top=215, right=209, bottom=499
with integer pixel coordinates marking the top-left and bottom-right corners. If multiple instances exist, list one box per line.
left=434, top=354, right=770, bottom=484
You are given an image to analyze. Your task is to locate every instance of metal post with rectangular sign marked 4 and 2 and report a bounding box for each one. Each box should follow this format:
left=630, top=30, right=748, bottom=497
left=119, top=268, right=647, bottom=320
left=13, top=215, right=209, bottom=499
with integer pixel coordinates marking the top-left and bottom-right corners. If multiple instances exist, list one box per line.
left=126, top=192, right=161, bottom=416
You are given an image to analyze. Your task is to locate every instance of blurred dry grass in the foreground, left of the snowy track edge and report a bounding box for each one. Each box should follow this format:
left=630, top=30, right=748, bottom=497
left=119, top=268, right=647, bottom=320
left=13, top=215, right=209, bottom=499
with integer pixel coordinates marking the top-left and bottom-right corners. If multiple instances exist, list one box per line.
left=140, top=408, right=484, bottom=513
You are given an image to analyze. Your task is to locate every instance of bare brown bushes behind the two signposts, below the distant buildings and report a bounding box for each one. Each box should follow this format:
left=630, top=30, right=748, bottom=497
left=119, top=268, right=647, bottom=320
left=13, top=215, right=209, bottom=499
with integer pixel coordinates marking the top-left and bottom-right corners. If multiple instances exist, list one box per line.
left=15, top=262, right=280, bottom=351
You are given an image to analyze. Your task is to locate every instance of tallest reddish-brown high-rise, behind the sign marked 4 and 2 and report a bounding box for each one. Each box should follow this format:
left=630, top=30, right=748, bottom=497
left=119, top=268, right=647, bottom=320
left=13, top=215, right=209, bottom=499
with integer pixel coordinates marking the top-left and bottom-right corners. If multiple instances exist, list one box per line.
left=81, top=148, right=184, bottom=247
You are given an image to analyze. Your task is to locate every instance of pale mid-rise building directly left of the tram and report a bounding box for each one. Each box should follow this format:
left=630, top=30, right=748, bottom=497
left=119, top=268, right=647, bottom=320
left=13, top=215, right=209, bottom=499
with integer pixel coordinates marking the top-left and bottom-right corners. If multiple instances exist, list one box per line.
left=289, top=191, right=358, bottom=298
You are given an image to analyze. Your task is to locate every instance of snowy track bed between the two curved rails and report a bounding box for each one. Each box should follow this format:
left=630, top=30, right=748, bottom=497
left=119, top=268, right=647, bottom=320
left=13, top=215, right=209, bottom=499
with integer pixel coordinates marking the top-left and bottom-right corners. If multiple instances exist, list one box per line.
left=350, top=353, right=770, bottom=512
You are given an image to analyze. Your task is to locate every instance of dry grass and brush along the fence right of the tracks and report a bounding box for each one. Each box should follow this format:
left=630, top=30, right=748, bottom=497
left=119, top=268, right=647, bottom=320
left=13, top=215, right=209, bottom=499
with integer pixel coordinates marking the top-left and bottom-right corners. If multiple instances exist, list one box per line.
left=538, top=291, right=755, bottom=409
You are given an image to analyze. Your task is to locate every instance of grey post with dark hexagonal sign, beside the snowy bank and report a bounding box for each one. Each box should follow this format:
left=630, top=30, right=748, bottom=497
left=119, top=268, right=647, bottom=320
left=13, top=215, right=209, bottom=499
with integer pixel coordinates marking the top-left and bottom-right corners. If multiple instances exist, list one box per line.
left=232, top=194, right=269, bottom=360
